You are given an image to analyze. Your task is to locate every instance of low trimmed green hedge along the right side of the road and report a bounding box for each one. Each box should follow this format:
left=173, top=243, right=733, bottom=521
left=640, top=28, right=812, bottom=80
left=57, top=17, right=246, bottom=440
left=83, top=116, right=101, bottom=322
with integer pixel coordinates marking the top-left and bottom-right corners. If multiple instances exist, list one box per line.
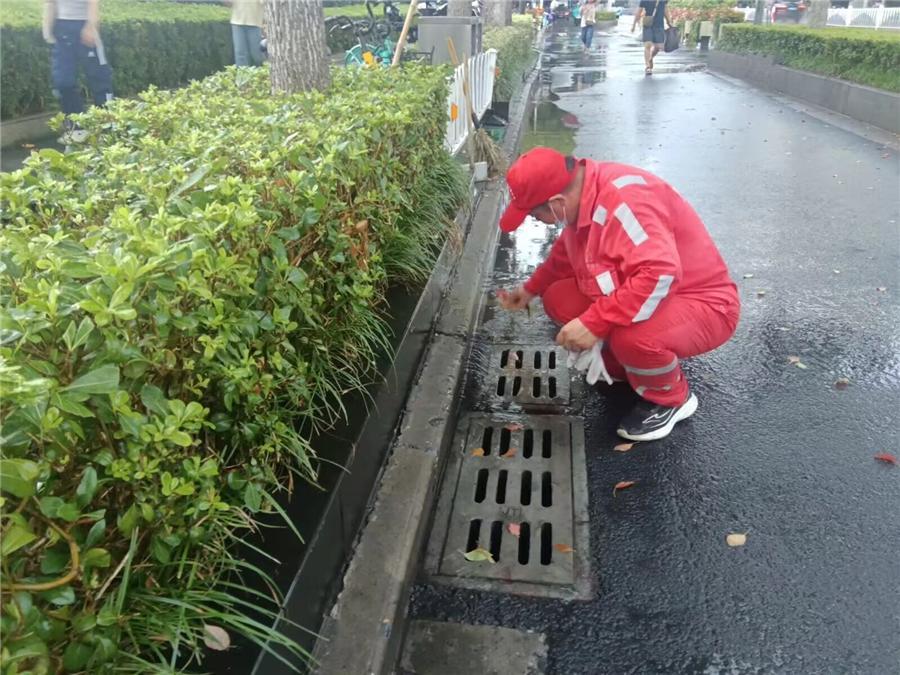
left=718, top=24, right=900, bottom=92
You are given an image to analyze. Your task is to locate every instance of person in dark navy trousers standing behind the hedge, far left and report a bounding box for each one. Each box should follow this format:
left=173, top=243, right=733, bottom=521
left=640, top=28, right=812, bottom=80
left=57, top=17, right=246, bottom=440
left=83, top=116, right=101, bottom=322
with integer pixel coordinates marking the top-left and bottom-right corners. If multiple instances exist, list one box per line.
left=43, top=0, right=112, bottom=143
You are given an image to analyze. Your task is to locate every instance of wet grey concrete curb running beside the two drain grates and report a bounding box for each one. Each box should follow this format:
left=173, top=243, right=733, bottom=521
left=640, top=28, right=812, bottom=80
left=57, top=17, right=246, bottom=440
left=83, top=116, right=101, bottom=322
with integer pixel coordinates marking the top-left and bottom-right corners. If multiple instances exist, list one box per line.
left=313, top=64, right=539, bottom=675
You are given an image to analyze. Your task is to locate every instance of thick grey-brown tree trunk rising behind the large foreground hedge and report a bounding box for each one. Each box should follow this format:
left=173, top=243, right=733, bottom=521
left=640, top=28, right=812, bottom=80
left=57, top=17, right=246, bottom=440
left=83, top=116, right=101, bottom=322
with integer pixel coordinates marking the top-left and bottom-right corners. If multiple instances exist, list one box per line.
left=266, top=0, right=331, bottom=93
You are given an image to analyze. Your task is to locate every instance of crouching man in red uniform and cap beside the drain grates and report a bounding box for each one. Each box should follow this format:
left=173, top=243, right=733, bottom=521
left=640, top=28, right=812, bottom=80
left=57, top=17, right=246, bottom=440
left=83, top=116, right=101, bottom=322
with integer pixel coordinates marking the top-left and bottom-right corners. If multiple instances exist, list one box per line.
left=498, top=148, right=740, bottom=441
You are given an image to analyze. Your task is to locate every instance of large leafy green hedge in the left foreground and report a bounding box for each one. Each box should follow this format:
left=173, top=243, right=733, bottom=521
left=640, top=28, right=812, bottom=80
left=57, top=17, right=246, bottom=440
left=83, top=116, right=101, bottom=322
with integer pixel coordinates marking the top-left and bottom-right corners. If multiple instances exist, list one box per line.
left=0, top=66, right=467, bottom=675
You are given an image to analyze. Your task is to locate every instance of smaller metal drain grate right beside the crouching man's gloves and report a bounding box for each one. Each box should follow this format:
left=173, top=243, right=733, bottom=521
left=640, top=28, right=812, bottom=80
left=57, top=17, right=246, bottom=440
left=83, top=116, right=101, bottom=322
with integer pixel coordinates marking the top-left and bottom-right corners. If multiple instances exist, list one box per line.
left=489, top=345, right=569, bottom=405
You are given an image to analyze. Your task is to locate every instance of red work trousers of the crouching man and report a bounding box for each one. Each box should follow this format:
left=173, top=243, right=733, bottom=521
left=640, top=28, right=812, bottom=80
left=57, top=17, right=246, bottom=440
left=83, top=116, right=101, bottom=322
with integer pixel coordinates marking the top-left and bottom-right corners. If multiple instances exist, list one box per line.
left=542, top=278, right=740, bottom=407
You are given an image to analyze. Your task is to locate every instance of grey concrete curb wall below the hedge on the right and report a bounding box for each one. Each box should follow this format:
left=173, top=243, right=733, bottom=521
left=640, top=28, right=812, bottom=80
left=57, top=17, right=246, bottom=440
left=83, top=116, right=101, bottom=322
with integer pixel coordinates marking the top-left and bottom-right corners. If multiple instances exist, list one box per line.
left=708, top=51, right=900, bottom=134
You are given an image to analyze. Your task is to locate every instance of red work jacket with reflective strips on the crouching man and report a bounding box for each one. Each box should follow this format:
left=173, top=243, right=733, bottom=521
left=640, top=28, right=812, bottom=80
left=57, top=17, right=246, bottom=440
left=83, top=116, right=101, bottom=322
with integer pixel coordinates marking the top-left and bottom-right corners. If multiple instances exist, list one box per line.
left=525, top=159, right=740, bottom=337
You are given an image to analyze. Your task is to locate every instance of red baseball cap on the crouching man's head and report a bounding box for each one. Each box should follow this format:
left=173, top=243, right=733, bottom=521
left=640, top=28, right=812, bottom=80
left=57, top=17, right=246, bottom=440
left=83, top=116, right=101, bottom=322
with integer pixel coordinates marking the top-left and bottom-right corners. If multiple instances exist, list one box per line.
left=500, top=148, right=575, bottom=232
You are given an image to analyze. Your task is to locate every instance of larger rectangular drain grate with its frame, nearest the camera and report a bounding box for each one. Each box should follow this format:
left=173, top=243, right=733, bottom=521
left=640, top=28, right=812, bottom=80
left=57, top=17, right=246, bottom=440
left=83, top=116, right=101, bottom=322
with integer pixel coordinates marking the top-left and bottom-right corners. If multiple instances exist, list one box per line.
left=425, top=413, right=593, bottom=600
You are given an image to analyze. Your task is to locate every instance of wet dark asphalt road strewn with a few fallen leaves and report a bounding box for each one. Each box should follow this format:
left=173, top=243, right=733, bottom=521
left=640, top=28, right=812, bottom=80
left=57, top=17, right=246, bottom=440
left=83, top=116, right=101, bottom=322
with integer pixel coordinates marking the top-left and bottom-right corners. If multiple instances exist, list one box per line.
left=411, top=21, right=900, bottom=675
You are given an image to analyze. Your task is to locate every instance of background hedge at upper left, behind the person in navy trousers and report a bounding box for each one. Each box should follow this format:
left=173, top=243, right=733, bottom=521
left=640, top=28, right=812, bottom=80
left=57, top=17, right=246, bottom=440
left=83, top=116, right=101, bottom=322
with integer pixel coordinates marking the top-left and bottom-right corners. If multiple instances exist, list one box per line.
left=0, top=0, right=234, bottom=119
